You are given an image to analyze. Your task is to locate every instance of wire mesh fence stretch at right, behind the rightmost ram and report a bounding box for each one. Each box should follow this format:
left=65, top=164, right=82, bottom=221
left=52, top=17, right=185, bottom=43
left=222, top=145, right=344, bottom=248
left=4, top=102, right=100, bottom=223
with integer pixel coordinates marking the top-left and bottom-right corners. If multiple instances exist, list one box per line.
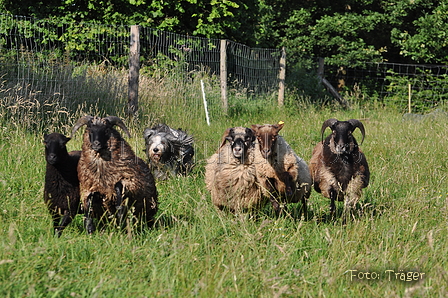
left=325, top=62, right=448, bottom=112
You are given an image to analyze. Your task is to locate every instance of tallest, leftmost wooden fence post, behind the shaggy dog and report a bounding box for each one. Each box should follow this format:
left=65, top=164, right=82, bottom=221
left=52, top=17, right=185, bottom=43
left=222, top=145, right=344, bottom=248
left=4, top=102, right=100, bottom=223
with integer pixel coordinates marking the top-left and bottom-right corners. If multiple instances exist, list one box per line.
left=128, top=25, right=140, bottom=116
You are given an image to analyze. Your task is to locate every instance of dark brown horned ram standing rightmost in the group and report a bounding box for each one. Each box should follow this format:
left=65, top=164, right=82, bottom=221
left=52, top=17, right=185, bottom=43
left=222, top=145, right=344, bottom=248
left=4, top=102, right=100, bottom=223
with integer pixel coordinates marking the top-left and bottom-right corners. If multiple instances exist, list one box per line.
left=310, top=118, right=370, bottom=216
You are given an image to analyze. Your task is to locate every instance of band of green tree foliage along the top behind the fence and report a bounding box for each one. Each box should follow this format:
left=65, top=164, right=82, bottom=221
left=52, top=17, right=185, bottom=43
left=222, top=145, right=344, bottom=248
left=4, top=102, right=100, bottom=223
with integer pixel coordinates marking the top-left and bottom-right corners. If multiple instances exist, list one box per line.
left=2, top=0, right=448, bottom=67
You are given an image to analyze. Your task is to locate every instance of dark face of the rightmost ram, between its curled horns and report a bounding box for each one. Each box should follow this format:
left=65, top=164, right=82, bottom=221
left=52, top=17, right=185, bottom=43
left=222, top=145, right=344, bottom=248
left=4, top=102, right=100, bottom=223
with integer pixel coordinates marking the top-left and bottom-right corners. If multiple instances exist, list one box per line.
left=327, top=121, right=358, bottom=155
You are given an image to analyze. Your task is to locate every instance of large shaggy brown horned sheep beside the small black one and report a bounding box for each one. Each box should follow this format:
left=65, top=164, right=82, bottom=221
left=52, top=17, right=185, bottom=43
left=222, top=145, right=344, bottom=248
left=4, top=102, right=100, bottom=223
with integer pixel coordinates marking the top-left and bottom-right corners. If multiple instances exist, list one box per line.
left=72, top=116, right=158, bottom=234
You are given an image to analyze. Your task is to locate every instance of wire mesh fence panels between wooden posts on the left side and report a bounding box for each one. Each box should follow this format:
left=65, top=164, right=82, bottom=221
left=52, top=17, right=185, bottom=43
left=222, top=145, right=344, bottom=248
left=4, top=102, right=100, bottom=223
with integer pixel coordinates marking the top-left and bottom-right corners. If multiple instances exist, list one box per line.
left=0, top=14, right=280, bottom=121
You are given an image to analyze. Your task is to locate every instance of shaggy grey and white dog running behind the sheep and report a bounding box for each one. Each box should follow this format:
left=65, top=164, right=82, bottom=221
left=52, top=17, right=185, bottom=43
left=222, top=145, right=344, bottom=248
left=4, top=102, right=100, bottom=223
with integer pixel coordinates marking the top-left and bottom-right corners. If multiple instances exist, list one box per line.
left=143, top=124, right=194, bottom=180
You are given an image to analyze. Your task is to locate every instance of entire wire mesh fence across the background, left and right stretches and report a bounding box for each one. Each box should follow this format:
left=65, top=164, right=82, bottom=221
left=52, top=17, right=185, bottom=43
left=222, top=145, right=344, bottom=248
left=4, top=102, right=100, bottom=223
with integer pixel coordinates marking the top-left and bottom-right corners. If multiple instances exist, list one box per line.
left=0, top=14, right=448, bottom=117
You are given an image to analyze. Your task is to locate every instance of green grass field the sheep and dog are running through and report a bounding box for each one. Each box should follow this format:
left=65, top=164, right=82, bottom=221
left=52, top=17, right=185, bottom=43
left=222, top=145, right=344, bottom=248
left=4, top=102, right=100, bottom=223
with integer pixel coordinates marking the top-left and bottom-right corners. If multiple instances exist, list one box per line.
left=0, top=74, right=448, bottom=297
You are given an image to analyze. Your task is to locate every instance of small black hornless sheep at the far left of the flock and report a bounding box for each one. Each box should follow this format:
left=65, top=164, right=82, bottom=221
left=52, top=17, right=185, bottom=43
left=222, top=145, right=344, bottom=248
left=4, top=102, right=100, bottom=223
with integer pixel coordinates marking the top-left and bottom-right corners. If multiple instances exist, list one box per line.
left=43, top=133, right=81, bottom=237
